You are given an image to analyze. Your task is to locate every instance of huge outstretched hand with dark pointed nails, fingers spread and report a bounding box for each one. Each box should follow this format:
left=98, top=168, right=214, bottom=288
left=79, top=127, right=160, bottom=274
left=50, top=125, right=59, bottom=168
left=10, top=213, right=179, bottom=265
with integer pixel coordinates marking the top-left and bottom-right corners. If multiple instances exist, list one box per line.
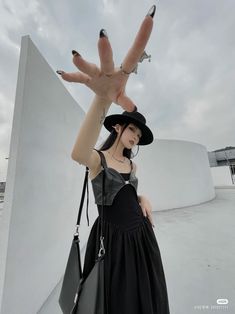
left=57, top=5, right=156, bottom=111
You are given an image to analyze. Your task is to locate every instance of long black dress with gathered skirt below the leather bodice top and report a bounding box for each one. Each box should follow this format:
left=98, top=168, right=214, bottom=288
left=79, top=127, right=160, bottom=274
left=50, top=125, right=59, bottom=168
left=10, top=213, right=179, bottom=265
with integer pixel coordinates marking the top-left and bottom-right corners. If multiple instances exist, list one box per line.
left=83, top=153, right=170, bottom=314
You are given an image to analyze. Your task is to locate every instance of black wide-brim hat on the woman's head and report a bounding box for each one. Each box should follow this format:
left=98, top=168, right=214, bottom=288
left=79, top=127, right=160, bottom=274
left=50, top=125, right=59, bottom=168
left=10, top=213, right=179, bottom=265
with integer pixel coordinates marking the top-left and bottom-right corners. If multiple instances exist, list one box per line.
left=104, top=111, right=153, bottom=145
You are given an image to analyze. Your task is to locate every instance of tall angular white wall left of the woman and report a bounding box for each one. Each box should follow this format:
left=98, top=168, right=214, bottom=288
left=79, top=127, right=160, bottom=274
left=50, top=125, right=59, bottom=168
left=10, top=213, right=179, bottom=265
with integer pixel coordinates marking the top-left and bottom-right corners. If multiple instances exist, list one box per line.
left=0, top=36, right=98, bottom=314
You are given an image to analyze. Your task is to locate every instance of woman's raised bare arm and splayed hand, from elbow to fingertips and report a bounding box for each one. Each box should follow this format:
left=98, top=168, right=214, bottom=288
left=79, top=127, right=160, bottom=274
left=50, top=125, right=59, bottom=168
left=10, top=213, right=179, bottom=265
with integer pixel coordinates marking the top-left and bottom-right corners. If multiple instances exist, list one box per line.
left=57, top=5, right=156, bottom=169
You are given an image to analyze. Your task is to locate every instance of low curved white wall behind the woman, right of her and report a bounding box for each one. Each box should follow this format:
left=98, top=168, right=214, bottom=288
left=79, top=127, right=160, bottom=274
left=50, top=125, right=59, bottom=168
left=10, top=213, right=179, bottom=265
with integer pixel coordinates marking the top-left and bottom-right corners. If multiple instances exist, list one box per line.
left=134, top=139, right=215, bottom=211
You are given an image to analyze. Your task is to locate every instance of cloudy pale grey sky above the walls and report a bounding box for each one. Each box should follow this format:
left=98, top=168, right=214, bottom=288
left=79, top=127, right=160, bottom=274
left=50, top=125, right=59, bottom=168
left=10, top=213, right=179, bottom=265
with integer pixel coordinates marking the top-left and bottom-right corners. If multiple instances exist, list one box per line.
left=0, top=0, right=235, bottom=181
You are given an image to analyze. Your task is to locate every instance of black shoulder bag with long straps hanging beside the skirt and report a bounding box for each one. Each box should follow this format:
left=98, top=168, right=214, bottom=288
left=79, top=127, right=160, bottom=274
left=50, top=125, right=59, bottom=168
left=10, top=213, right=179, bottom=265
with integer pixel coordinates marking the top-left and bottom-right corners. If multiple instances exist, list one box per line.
left=59, top=165, right=105, bottom=314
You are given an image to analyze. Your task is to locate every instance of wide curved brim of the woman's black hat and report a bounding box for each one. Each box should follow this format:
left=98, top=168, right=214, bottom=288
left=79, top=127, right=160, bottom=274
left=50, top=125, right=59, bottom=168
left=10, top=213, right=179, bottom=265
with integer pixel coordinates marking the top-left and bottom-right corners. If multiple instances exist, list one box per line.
left=104, top=114, right=153, bottom=145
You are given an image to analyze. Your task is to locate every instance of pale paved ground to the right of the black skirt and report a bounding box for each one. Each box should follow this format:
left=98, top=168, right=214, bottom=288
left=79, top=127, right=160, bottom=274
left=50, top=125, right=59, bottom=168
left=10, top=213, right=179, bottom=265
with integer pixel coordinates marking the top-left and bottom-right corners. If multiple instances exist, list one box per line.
left=153, top=188, right=235, bottom=314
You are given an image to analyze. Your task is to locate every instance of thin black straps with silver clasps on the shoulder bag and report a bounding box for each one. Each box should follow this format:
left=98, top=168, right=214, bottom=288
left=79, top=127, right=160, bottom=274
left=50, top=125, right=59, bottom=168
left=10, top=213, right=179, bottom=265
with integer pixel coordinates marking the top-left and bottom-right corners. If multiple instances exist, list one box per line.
left=74, top=150, right=106, bottom=258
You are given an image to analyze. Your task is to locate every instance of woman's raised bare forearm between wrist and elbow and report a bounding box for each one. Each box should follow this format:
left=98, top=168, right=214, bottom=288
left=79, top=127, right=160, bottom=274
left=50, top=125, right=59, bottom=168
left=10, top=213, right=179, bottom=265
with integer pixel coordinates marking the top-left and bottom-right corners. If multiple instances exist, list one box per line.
left=71, top=95, right=112, bottom=163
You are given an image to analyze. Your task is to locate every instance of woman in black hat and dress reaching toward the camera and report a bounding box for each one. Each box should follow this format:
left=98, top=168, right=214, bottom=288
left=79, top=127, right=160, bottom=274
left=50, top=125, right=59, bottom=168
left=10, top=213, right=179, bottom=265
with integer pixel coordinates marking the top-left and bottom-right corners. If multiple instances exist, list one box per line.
left=57, top=6, right=169, bottom=314
